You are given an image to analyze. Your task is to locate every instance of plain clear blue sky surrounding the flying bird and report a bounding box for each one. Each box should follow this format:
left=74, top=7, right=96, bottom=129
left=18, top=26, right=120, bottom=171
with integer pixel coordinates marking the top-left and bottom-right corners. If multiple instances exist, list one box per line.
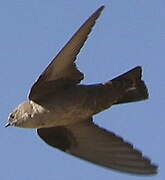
left=0, top=0, right=165, bottom=180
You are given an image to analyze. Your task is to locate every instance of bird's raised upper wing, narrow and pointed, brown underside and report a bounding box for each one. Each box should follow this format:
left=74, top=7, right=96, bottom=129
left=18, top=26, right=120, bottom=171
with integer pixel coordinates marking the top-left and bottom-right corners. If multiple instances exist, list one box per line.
left=29, top=6, right=104, bottom=101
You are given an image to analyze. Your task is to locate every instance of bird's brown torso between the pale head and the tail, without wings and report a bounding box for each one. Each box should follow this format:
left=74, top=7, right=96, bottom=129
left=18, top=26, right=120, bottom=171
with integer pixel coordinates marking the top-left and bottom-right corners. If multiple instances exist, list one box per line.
left=30, top=85, right=109, bottom=127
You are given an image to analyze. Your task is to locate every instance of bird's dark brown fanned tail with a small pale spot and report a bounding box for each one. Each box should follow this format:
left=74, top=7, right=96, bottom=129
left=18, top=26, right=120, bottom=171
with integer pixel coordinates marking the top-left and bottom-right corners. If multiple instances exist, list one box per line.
left=111, top=66, right=148, bottom=104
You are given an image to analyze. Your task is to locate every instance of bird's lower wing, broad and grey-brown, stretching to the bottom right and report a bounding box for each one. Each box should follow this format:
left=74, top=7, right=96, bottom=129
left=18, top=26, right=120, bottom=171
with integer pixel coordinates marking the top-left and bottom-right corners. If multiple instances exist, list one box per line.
left=37, top=120, right=157, bottom=175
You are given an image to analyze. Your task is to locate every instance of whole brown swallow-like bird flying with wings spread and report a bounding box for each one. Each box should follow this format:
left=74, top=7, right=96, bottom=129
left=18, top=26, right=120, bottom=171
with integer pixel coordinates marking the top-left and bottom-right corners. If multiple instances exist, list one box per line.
left=6, top=6, right=158, bottom=175
